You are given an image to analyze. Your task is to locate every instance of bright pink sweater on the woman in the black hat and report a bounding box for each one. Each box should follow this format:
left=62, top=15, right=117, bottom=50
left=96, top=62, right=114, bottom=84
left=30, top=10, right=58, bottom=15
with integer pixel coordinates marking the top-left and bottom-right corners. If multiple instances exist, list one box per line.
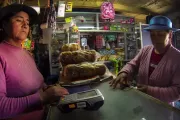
left=0, top=43, right=43, bottom=119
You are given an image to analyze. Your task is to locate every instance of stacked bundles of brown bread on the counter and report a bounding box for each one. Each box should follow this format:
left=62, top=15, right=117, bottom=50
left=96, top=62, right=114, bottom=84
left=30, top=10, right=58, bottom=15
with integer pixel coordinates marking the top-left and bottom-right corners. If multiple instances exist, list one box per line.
left=60, top=43, right=106, bottom=80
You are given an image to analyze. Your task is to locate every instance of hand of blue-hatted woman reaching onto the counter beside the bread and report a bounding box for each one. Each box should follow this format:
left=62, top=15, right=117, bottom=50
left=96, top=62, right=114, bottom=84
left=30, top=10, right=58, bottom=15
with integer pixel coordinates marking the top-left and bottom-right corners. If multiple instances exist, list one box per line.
left=109, top=73, right=129, bottom=88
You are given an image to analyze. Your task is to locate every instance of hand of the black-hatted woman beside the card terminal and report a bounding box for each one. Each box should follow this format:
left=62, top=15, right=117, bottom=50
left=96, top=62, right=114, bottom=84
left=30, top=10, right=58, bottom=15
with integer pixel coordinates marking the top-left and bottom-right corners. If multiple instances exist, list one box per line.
left=39, top=85, right=69, bottom=104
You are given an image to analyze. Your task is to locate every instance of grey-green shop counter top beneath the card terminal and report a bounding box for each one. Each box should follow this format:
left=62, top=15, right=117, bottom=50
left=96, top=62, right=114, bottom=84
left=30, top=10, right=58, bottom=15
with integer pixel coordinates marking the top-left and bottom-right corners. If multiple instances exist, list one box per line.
left=46, top=82, right=180, bottom=120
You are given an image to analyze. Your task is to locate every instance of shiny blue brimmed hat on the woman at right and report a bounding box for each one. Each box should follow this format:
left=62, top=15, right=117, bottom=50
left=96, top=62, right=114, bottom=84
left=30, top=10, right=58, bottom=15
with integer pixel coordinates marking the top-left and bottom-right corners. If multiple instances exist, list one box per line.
left=144, top=15, right=179, bottom=31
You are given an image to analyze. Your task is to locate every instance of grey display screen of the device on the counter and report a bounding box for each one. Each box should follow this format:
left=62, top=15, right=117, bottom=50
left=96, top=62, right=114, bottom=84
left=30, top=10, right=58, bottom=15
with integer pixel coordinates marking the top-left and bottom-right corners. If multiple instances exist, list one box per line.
left=77, top=90, right=97, bottom=99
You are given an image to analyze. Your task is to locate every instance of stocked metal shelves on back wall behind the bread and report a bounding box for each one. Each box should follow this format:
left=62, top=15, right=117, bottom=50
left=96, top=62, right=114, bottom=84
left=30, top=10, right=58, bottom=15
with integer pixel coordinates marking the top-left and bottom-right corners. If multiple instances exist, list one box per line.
left=44, top=12, right=137, bottom=75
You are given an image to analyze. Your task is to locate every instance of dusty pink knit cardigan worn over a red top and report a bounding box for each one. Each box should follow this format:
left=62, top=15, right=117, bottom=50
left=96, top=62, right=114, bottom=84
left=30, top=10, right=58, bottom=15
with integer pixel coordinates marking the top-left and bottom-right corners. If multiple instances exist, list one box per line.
left=120, top=46, right=180, bottom=103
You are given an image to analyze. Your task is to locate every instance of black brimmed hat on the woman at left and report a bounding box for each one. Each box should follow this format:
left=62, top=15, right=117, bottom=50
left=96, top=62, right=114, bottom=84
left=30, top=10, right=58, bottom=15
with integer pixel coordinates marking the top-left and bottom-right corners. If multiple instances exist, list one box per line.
left=0, top=4, right=39, bottom=28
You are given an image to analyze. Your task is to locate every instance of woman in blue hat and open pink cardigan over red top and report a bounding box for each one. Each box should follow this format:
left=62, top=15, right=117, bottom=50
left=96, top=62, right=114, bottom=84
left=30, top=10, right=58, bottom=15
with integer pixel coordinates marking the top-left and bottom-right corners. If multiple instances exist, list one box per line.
left=110, top=16, right=180, bottom=103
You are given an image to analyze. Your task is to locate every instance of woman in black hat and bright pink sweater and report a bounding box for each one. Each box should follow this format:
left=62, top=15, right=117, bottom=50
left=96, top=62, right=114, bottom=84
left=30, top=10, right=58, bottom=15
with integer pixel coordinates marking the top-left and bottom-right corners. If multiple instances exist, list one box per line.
left=0, top=4, right=68, bottom=120
